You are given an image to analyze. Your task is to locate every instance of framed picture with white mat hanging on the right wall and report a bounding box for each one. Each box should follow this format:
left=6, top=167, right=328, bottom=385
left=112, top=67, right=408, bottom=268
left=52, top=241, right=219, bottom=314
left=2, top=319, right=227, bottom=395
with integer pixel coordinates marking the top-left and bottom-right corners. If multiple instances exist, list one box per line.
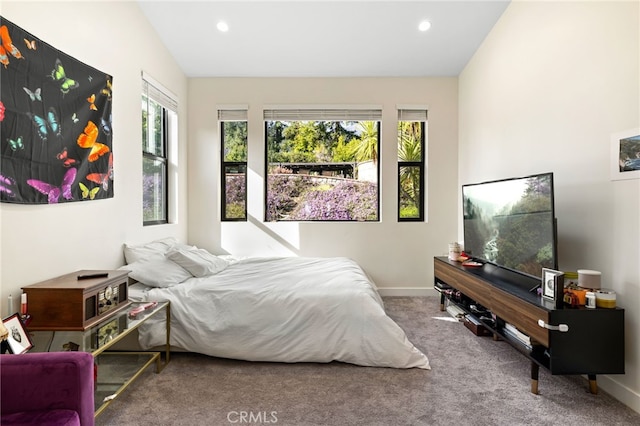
left=610, top=128, right=640, bottom=180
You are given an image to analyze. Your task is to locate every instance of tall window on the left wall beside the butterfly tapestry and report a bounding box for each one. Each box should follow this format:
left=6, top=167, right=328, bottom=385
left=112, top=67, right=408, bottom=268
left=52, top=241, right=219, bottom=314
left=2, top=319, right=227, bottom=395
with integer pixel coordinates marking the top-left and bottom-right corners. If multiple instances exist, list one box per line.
left=142, top=76, right=177, bottom=226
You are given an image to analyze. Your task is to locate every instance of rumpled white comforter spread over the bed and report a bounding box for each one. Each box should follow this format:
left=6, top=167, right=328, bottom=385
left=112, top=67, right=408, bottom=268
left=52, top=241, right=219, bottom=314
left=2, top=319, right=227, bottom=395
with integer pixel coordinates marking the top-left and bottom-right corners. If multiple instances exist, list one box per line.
left=140, top=257, right=430, bottom=369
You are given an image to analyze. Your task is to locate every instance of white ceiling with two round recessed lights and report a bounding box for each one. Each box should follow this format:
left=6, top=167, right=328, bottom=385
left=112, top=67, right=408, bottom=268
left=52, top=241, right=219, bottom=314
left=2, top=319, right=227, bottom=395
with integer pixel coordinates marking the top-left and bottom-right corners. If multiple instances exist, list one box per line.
left=138, top=0, right=509, bottom=77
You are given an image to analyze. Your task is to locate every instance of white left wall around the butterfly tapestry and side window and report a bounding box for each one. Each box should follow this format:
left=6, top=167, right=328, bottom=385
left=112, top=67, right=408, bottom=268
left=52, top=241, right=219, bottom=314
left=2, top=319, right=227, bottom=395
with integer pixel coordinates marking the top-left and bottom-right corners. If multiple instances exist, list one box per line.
left=0, top=0, right=187, bottom=316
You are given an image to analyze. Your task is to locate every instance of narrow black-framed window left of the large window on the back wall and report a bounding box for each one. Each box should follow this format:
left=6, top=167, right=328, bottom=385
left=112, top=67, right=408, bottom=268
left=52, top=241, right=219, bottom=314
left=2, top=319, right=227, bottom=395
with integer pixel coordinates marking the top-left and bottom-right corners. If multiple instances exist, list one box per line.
left=218, top=109, right=247, bottom=221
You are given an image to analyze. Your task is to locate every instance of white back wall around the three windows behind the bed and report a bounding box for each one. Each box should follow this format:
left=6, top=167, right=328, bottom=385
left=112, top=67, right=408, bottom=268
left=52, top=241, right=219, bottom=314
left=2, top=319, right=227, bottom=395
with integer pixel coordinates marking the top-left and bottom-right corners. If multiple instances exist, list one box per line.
left=189, top=78, right=458, bottom=294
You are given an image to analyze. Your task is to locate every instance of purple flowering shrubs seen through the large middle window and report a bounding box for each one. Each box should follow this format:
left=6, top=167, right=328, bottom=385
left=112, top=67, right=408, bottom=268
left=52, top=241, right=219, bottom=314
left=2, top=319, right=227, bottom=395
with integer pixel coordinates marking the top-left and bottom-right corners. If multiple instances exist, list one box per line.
left=267, top=175, right=378, bottom=221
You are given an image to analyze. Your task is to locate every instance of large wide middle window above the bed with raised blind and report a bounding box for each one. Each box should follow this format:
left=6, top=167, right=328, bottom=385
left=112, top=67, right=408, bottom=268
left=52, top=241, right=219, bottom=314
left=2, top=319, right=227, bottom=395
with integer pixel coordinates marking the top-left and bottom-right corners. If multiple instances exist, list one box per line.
left=264, top=109, right=382, bottom=222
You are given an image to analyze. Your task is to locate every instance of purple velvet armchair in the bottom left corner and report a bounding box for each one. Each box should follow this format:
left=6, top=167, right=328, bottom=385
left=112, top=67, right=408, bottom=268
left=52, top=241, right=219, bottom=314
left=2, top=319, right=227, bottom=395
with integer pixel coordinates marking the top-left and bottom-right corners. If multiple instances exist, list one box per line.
left=0, top=352, right=95, bottom=426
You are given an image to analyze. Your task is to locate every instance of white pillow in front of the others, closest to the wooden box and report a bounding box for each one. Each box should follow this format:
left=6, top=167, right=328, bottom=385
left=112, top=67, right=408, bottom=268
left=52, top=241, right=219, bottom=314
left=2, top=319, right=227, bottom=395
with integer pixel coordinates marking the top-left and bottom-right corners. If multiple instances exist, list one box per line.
left=120, top=257, right=193, bottom=287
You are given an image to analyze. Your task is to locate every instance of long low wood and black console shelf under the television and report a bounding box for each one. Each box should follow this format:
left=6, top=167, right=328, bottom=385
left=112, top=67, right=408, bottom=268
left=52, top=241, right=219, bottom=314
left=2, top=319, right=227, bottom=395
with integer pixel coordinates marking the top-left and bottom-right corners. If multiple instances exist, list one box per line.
left=434, top=257, right=624, bottom=393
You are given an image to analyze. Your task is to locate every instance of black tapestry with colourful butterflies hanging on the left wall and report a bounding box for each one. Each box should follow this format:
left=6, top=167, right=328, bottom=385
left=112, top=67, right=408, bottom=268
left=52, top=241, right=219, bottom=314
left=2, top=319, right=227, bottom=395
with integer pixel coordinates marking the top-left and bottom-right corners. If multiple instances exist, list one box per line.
left=0, top=16, right=114, bottom=204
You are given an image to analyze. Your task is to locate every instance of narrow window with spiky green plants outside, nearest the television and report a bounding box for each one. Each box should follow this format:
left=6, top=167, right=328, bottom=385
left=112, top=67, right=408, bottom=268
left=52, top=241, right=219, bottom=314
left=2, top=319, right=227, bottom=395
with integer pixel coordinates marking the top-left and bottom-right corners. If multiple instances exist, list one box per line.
left=398, top=109, right=427, bottom=221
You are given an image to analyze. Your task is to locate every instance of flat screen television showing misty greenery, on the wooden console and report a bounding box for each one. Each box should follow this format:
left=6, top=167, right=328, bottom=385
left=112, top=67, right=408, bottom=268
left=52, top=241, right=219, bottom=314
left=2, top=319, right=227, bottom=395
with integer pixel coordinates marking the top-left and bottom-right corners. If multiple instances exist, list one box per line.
left=462, top=173, right=558, bottom=278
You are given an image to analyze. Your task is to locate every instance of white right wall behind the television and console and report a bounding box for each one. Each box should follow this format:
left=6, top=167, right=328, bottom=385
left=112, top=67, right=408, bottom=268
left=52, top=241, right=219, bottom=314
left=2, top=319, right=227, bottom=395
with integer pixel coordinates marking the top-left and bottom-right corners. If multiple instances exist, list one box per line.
left=458, top=1, right=640, bottom=412
